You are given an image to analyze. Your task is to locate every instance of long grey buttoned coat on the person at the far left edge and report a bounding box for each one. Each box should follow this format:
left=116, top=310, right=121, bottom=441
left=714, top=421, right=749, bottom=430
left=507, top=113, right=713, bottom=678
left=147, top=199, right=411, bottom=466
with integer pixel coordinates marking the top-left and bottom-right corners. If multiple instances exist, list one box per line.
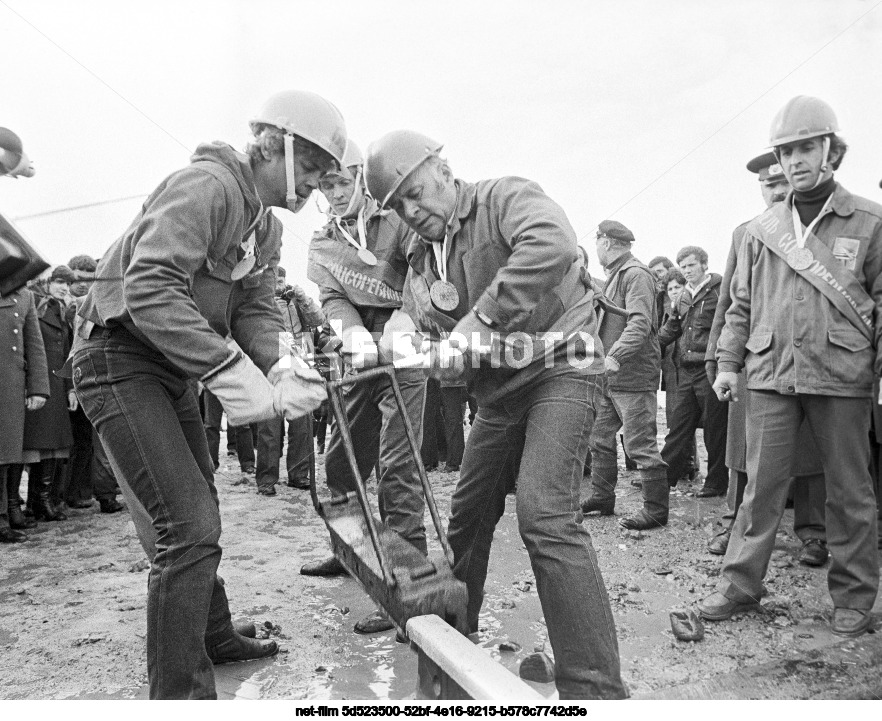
left=0, top=288, right=49, bottom=462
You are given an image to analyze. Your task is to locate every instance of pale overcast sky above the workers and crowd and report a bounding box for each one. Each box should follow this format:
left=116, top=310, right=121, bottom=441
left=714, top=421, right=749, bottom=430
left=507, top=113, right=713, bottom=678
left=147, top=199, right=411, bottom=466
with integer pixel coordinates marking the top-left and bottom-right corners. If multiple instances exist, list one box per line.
left=0, top=0, right=882, bottom=290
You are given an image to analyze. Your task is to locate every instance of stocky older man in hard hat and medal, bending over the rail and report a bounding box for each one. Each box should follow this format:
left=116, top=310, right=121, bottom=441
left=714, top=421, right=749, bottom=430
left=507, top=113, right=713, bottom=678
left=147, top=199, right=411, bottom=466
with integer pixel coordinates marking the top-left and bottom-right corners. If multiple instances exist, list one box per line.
left=366, top=130, right=625, bottom=699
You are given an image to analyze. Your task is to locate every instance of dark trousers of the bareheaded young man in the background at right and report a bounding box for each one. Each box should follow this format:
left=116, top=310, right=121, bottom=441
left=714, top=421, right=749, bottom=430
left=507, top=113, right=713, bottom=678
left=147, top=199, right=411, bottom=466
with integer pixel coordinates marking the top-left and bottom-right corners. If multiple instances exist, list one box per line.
left=662, top=365, right=729, bottom=491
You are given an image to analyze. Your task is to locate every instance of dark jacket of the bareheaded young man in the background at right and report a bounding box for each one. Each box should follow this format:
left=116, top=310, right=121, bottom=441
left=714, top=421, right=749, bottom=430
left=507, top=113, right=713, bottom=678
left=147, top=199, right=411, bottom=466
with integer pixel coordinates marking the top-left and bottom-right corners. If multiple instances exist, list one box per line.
left=658, top=273, right=722, bottom=366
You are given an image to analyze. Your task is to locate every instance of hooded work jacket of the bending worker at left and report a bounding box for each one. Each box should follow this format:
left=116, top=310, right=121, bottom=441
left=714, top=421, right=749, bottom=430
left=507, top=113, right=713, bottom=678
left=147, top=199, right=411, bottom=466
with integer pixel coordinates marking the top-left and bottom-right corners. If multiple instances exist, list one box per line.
left=79, top=143, right=284, bottom=378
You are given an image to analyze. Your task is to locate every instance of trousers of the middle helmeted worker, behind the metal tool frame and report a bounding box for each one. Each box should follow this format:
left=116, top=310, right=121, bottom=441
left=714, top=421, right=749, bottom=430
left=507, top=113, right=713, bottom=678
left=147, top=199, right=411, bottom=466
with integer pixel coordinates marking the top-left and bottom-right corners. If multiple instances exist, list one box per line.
left=325, top=370, right=426, bottom=554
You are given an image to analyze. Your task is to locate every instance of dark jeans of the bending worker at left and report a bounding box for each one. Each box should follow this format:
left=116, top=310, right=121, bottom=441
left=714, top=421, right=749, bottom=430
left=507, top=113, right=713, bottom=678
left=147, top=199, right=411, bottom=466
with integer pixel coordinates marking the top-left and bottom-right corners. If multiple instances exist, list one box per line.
left=73, top=328, right=232, bottom=699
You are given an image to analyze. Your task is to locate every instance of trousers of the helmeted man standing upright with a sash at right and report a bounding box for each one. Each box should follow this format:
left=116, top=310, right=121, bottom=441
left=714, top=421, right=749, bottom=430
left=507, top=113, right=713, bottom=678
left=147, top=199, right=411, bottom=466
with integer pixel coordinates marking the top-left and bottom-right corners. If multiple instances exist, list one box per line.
left=717, top=390, right=879, bottom=611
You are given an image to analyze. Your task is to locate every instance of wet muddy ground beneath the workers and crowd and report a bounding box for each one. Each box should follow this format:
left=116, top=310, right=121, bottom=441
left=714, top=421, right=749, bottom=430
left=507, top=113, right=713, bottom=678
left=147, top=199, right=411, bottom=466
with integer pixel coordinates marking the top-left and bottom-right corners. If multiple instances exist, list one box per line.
left=0, top=404, right=872, bottom=699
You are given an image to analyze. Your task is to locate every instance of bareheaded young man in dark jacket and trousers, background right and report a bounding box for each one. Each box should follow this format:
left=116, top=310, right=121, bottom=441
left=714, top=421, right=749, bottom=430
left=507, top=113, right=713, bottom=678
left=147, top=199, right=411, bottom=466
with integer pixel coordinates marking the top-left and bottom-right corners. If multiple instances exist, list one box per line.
left=659, top=245, right=729, bottom=498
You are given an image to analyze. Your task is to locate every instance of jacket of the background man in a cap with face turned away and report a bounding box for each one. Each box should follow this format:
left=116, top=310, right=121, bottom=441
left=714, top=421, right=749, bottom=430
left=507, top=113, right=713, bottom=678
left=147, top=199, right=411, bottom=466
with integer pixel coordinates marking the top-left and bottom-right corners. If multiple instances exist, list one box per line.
left=597, top=252, right=661, bottom=391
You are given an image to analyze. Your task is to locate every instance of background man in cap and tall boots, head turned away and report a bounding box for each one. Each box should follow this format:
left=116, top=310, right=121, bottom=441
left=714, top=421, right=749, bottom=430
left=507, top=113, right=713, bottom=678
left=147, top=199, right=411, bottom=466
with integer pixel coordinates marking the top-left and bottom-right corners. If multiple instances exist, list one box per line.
left=582, top=220, right=670, bottom=530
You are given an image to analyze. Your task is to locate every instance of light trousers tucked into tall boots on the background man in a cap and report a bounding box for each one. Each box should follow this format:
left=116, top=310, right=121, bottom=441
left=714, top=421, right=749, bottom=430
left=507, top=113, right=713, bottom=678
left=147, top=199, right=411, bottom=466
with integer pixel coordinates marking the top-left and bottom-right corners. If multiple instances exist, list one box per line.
left=590, top=378, right=667, bottom=499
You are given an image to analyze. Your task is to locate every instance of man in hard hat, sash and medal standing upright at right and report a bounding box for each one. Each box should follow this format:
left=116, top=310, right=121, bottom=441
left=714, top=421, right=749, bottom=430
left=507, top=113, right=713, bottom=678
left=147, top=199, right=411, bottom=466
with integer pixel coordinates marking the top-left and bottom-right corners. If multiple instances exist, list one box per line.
left=699, top=96, right=882, bottom=637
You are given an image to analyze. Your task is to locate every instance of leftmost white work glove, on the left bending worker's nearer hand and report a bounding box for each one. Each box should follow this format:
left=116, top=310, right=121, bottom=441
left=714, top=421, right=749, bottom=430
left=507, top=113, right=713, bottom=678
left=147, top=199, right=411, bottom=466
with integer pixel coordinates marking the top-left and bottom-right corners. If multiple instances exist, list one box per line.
left=200, top=338, right=279, bottom=426
